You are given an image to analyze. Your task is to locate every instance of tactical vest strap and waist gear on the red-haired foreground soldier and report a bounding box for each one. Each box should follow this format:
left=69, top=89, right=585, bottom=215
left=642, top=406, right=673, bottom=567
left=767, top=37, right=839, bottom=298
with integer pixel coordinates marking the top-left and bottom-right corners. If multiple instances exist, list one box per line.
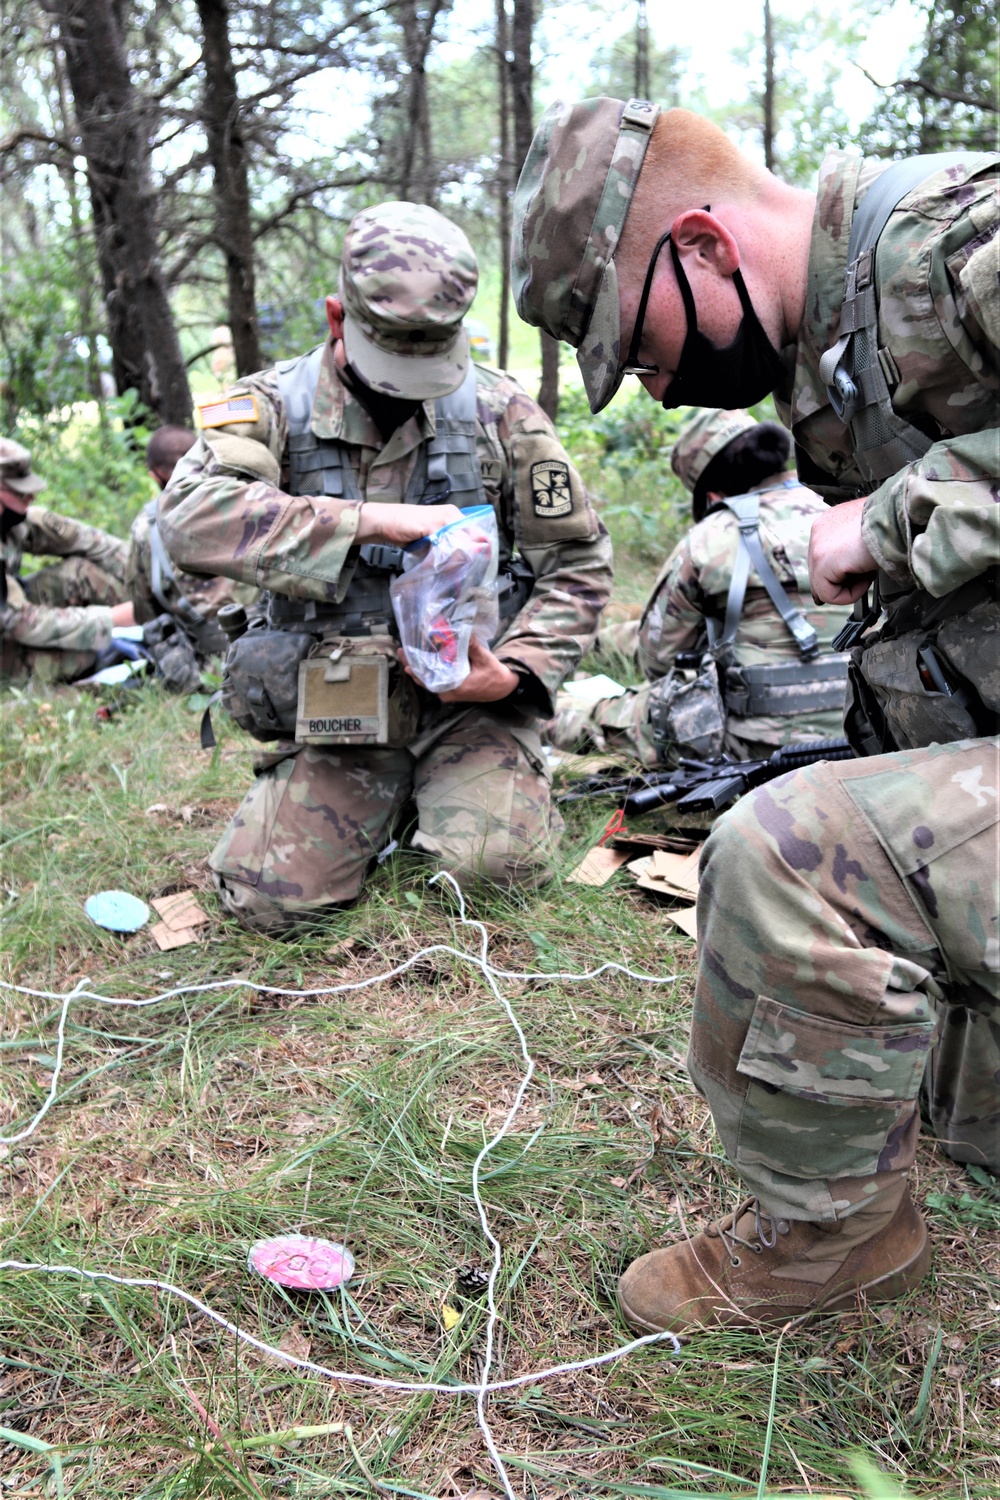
left=820, top=152, right=1000, bottom=755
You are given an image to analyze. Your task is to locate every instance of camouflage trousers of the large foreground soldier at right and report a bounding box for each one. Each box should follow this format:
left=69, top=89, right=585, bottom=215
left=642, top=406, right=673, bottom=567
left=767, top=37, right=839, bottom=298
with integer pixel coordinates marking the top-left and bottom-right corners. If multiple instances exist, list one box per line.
left=688, top=740, right=1000, bottom=1220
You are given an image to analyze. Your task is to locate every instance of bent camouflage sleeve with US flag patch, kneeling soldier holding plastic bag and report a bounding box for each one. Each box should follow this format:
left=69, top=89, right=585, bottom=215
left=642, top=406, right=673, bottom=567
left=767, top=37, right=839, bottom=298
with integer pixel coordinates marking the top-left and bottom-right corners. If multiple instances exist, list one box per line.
left=157, top=371, right=361, bottom=600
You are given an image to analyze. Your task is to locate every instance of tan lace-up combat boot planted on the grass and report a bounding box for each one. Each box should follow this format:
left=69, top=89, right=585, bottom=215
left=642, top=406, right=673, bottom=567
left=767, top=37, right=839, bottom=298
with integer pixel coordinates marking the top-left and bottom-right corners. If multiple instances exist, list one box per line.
left=618, top=1184, right=931, bottom=1334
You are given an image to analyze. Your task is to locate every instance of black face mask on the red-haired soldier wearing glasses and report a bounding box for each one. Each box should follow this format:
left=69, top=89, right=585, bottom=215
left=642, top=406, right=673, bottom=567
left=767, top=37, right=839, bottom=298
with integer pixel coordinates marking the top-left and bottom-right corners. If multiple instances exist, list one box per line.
left=625, top=225, right=784, bottom=411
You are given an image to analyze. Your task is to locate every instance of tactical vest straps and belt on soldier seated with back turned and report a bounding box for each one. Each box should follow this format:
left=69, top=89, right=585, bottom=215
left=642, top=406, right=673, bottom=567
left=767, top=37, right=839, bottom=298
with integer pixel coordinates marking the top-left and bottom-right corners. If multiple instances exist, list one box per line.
left=709, top=480, right=849, bottom=719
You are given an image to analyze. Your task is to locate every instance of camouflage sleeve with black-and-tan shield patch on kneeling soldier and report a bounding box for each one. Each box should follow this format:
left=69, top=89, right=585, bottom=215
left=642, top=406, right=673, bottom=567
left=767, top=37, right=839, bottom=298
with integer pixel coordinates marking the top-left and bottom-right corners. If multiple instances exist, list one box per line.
left=478, top=375, right=612, bottom=716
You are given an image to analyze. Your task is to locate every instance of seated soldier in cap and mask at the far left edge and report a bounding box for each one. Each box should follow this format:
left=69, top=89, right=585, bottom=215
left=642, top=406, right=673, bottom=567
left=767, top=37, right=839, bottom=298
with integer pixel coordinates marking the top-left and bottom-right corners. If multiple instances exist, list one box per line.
left=0, top=438, right=133, bottom=683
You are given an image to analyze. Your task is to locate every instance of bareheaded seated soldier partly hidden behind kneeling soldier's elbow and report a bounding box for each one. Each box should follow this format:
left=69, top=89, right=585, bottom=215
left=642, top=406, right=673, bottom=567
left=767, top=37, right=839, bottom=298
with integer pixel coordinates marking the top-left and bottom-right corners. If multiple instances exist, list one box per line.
left=124, top=426, right=259, bottom=692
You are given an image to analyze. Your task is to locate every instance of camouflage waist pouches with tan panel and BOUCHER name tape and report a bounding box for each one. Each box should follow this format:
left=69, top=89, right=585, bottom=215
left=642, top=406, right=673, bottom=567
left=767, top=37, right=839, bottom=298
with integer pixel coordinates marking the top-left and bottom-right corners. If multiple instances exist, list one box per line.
left=222, top=618, right=420, bottom=749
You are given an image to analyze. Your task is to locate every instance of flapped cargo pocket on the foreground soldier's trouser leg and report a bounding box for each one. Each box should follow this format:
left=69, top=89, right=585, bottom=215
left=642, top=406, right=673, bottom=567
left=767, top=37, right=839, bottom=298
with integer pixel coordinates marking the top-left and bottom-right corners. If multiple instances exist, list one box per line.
left=736, top=998, right=936, bottom=1178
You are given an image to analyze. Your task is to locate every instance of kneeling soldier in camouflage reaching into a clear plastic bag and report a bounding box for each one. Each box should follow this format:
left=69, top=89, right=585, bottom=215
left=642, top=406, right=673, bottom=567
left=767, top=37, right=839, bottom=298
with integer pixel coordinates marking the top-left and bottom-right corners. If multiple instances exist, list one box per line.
left=159, top=203, right=612, bottom=932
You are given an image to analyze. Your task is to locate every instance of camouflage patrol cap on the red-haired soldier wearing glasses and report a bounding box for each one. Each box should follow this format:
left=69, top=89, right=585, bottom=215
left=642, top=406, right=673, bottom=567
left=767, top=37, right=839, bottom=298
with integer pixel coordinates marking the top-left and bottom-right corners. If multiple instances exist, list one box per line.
left=511, top=99, right=660, bottom=411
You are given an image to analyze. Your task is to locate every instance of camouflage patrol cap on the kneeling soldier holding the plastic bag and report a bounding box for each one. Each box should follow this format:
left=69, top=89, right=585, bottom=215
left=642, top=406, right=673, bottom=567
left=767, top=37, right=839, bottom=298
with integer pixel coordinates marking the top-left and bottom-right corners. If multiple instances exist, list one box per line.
left=339, top=203, right=480, bottom=401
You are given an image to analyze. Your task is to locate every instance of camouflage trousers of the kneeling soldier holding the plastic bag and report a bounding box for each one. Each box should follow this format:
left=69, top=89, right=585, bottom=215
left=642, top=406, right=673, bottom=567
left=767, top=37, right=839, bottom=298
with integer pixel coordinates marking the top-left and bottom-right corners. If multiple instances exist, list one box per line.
left=208, top=708, right=562, bottom=933
